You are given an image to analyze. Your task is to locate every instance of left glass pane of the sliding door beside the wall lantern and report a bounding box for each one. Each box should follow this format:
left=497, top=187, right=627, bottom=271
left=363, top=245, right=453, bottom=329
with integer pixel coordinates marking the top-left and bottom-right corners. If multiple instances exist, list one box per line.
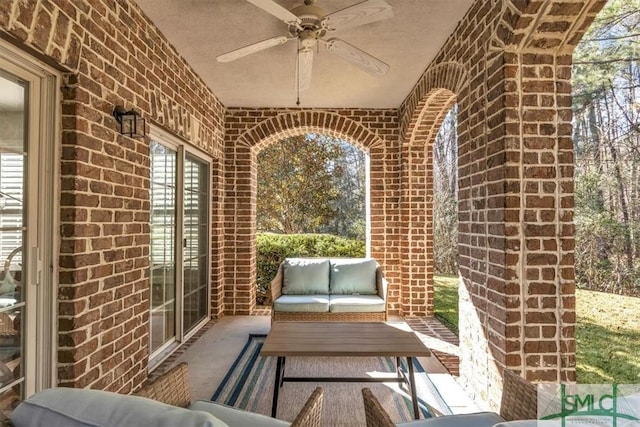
left=150, top=141, right=177, bottom=352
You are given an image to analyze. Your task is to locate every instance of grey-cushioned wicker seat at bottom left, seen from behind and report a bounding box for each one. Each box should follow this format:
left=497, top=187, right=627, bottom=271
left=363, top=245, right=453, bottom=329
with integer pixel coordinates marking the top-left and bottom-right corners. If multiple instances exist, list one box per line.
left=11, top=363, right=323, bottom=427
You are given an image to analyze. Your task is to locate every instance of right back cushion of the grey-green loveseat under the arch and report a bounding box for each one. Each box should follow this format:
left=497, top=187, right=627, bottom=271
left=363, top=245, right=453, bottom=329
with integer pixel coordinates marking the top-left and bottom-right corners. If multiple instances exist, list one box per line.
left=330, top=258, right=378, bottom=295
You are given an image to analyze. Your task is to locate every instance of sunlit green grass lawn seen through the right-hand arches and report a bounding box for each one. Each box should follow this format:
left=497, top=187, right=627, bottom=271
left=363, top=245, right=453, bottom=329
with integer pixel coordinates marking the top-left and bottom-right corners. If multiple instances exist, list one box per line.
left=434, top=276, right=640, bottom=384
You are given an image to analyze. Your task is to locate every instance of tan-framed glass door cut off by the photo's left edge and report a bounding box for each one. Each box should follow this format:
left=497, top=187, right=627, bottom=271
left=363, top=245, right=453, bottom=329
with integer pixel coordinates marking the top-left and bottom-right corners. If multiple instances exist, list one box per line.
left=0, top=43, right=56, bottom=414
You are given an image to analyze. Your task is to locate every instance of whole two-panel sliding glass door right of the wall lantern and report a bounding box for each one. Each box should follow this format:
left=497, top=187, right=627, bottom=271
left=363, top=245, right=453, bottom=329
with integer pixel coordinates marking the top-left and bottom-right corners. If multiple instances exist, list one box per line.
left=150, top=131, right=210, bottom=365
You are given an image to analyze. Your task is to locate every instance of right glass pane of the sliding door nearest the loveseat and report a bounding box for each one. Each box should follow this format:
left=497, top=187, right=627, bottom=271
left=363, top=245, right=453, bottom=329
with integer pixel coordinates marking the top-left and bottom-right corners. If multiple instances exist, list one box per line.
left=183, top=153, right=209, bottom=334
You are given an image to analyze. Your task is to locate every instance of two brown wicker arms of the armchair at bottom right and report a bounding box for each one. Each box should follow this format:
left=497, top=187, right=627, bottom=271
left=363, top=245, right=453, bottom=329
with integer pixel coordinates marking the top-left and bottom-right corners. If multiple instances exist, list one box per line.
left=362, top=369, right=538, bottom=427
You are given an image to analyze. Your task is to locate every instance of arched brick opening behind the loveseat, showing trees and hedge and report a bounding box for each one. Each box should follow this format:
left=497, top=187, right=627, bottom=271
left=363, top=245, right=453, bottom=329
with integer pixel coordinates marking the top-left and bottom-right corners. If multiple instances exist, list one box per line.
left=256, top=133, right=370, bottom=306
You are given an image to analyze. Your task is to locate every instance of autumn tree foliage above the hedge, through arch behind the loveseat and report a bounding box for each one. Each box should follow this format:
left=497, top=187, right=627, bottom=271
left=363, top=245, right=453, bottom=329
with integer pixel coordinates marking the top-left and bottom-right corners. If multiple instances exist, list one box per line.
left=256, top=134, right=366, bottom=240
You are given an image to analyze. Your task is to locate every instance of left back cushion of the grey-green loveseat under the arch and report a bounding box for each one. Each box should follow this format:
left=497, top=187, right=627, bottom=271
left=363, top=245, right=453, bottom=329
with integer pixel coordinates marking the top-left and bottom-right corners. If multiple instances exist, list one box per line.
left=282, top=258, right=330, bottom=295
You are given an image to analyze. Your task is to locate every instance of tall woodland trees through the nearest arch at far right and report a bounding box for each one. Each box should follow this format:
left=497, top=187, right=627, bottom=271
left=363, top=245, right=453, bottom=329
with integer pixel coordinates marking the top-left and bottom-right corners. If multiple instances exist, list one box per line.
left=573, top=0, right=640, bottom=293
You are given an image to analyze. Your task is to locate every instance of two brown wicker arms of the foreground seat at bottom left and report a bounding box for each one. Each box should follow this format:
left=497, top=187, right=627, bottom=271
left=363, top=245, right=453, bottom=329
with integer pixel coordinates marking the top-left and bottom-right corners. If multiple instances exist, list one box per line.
left=134, top=363, right=323, bottom=427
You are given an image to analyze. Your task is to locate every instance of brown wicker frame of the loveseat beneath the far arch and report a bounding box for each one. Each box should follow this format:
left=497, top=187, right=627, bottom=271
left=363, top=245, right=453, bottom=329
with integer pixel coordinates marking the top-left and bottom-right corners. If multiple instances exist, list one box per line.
left=270, top=263, right=389, bottom=322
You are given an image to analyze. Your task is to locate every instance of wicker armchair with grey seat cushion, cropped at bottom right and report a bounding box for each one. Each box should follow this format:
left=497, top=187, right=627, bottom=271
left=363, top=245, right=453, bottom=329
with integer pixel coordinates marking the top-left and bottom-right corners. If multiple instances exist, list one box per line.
left=362, top=369, right=538, bottom=427
